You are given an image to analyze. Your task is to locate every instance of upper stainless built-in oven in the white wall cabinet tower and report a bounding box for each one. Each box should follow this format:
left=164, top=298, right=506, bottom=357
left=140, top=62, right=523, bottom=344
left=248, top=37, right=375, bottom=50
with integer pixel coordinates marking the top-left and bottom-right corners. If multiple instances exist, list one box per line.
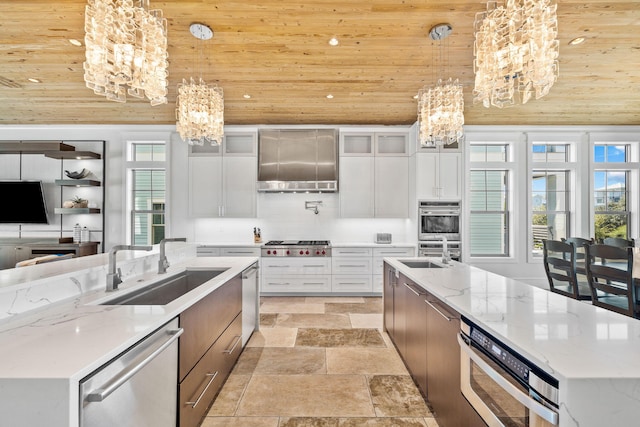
left=418, top=200, right=461, bottom=242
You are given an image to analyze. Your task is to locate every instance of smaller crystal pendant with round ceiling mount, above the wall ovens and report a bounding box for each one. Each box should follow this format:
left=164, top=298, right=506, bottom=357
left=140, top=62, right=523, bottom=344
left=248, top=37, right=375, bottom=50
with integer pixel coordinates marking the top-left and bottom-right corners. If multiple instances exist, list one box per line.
left=418, top=24, right=464, bottom=147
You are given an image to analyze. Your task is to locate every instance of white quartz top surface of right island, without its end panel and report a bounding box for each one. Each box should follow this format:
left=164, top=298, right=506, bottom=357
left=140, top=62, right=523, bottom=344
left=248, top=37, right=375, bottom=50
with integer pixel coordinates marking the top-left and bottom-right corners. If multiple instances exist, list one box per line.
left=385, top=258, right=640, bottom=382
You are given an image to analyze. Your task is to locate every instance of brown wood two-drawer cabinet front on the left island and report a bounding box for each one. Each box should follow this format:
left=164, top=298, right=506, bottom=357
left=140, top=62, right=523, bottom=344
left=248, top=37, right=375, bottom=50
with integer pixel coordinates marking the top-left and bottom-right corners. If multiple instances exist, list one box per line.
left=178, top=276, right=242, bottom=427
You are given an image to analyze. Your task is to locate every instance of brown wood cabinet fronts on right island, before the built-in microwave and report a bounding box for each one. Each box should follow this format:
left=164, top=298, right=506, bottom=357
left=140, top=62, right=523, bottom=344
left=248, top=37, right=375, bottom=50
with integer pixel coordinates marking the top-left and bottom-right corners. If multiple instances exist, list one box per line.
left=383, top=263, right=486, bottom=427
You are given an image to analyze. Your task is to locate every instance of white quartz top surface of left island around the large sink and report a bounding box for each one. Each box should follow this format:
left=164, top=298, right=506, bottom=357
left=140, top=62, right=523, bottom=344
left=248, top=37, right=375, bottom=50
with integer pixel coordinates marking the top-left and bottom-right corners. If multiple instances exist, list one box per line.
left=0, top=257, right=257, bottom=381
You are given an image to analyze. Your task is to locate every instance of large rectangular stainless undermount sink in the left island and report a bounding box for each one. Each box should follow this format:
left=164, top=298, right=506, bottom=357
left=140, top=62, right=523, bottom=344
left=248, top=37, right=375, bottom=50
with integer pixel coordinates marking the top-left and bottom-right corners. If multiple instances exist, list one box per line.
left=100, top=268, right=228, bottom=305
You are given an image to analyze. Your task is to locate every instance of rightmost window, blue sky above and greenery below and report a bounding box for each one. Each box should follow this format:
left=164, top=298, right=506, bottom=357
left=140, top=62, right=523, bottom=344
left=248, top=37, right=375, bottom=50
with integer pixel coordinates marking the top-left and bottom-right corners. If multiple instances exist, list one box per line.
left=593, top=144, right=631, bottom=242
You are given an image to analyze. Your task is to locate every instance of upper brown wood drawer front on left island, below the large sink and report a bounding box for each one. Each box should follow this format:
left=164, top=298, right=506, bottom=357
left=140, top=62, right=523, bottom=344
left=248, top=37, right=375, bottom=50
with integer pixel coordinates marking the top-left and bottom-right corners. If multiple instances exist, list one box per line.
left=178, top=275, right=242, bottom=381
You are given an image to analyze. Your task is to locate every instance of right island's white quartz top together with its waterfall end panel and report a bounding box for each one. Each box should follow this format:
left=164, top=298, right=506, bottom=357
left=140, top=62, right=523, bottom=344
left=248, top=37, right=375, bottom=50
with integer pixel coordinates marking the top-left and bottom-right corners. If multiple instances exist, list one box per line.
left=385, top=258, right=640, bottom=427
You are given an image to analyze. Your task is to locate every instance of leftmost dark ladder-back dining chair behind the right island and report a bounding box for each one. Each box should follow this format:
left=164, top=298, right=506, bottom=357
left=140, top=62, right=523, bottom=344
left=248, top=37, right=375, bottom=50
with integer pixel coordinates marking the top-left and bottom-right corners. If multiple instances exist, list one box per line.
left=542, top=239, right=591, bottom=300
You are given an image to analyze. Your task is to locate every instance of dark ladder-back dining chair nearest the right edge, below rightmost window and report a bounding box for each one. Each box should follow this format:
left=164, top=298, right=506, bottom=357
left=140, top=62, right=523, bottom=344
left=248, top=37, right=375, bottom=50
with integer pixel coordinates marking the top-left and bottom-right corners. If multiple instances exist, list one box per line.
left=587, top=244, right=640, bottom=317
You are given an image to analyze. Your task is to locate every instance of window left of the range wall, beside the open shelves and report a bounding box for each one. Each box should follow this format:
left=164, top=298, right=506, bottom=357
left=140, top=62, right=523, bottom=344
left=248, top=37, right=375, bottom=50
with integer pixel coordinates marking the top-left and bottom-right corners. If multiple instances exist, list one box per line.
left=127, top=142, right=166, bottom=245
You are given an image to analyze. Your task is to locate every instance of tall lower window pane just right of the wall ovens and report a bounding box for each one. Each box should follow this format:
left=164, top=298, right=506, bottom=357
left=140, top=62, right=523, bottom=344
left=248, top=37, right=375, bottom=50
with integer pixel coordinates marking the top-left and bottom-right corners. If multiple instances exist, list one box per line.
left=469, top=170, right=509, bottom=257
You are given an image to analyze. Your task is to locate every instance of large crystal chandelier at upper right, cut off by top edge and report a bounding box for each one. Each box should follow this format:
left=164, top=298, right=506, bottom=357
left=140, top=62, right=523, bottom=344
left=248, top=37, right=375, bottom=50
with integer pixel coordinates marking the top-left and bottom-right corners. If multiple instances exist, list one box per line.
left=473, top=0, right=560, bottom=108
